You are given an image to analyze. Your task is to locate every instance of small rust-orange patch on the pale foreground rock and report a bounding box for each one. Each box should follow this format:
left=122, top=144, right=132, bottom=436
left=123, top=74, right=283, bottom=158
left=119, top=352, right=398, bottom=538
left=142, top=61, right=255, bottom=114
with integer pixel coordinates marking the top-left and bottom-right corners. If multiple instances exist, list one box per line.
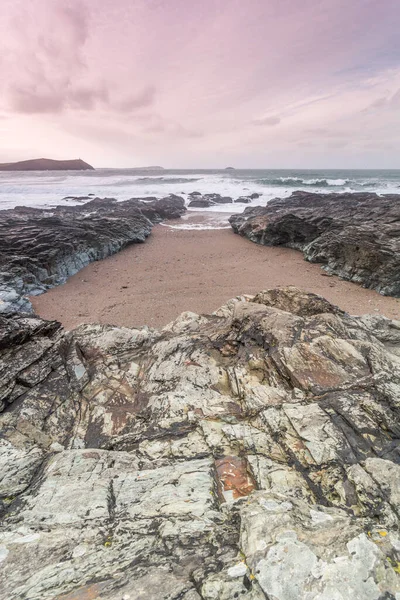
left=215, top=456, right=256, bottom=502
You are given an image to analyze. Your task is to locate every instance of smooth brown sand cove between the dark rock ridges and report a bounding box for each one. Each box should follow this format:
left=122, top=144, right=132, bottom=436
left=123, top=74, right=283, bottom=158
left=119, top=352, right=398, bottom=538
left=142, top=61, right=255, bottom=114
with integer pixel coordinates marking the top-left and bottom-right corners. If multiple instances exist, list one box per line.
left=31, top=225, right=400, bottom=329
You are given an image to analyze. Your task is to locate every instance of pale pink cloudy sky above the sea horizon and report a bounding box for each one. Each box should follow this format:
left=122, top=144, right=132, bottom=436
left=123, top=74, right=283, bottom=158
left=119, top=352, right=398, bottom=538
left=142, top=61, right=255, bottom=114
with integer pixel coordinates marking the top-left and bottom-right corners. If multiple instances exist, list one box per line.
left=0, top=0, right=400, bottom=168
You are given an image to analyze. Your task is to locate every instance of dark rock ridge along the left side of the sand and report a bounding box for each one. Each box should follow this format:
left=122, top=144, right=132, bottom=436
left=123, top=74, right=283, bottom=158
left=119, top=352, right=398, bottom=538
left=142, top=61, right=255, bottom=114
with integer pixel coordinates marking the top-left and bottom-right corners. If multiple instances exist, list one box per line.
left=0, top=196, right=186, bottom=314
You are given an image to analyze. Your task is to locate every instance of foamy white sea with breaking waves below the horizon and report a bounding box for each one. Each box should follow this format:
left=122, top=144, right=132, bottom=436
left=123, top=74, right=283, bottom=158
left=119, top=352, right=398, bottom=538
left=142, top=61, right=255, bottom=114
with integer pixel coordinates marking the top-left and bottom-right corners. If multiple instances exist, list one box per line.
left=0, top=169, right=400, bottom=229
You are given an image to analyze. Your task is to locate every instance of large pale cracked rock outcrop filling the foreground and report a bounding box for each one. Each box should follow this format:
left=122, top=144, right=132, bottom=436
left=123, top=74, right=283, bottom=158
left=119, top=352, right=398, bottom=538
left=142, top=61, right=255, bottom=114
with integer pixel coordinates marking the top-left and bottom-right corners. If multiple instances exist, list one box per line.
left=0, top=288, right=400, bottom=600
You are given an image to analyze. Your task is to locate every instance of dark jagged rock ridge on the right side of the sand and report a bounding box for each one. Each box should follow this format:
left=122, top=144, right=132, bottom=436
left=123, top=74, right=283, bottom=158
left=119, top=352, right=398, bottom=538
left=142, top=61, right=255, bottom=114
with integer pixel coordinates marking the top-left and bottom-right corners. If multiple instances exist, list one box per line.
left=230, top=192, right=400, bottom=297
